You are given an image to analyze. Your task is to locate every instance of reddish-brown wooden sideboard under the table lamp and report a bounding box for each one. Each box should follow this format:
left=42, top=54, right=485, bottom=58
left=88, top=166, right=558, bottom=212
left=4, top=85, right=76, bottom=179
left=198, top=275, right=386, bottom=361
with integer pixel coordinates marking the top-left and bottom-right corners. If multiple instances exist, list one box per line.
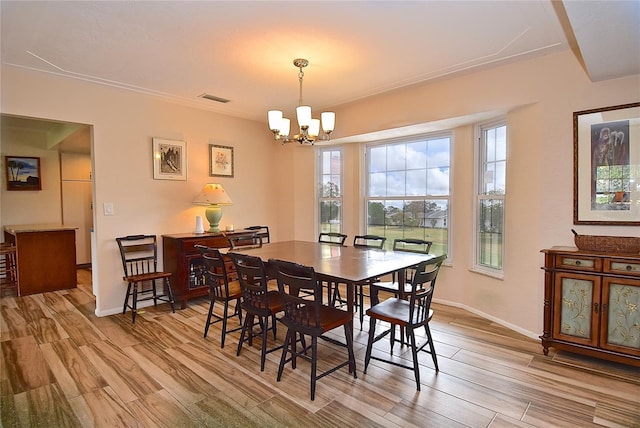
left=162, top=230, right=254, bottom=309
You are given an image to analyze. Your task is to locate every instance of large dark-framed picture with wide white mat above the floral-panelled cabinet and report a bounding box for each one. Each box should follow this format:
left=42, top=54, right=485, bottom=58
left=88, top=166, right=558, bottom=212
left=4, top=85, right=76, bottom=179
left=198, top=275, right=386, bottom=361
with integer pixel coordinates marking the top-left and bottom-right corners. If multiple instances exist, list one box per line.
left=573, top=103, right=640, bottom=226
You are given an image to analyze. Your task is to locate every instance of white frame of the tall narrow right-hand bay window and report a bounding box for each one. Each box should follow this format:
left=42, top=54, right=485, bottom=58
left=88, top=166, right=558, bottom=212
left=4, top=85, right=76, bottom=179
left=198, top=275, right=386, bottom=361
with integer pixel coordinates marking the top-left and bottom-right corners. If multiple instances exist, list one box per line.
left=470, top=117, right=509, bottom=279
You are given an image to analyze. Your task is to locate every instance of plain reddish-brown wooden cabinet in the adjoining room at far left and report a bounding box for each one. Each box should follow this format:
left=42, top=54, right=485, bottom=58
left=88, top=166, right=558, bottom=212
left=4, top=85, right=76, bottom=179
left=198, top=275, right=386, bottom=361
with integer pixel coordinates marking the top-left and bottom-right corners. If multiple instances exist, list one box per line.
left=4, top=225, right=78, bottom=296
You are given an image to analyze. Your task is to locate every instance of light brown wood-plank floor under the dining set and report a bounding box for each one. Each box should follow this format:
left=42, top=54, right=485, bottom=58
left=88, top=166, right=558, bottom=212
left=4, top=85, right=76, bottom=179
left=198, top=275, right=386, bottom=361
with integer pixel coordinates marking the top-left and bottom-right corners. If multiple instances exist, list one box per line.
left=0, top=270, right=640, bottom=428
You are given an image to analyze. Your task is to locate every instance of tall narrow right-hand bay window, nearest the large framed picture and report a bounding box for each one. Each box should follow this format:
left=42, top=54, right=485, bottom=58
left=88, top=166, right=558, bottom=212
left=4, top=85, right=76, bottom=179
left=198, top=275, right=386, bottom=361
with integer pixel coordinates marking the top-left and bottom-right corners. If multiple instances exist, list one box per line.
left=475, top=121, right=507, bottom=272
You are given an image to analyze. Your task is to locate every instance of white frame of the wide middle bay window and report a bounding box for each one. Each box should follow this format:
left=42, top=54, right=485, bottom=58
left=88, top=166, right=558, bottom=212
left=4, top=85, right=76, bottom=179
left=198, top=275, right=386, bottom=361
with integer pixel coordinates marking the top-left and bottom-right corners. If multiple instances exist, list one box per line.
left=361, top=129, right=455, bottom=256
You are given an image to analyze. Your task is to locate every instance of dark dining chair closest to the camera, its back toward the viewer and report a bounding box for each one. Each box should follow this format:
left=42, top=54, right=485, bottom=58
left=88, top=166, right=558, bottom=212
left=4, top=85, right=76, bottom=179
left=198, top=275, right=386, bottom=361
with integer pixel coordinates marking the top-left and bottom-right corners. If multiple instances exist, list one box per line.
left=269, top=259, right=357, bottom=401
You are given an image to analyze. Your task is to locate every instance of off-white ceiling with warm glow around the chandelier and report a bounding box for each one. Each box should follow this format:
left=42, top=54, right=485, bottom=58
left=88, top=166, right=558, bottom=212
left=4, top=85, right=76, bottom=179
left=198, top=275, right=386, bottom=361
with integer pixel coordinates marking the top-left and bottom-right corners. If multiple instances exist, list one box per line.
left=0, top=0, right=640, bottom=149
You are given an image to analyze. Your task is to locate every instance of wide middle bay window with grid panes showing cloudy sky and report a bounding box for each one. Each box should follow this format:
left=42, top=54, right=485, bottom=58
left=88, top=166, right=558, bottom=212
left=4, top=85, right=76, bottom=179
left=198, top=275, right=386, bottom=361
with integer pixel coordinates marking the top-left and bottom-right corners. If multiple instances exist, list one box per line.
left=366, top=134, right=451, bottom=255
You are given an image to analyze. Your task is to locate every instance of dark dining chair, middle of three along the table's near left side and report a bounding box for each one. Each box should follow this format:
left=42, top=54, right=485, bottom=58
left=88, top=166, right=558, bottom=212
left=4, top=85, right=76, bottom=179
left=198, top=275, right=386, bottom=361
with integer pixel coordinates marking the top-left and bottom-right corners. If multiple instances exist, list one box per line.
left=228, top=252, right=284, bottom=371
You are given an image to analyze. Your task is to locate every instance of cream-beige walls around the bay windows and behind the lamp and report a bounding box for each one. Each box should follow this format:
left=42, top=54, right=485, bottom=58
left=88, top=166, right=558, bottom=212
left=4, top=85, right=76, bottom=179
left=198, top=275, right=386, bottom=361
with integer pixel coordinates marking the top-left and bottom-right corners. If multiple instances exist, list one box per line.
left=2, top=52, right=640, bottom=336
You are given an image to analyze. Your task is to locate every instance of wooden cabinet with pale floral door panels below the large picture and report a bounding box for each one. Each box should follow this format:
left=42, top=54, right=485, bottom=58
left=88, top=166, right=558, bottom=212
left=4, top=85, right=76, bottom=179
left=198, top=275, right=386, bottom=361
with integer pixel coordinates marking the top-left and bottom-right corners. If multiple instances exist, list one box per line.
left=540, top=247, right=640, bottom=367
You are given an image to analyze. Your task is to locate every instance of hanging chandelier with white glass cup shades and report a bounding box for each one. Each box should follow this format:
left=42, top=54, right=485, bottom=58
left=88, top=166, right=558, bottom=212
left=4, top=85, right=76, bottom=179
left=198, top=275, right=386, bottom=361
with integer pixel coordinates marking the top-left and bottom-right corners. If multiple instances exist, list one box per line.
left=268, top=58, right=336, bottom=144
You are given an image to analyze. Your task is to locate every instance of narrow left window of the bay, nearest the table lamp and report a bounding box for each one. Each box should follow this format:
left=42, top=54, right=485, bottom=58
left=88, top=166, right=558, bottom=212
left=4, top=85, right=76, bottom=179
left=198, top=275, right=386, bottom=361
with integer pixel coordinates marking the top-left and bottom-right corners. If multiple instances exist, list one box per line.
left=318, top=148, right=342, bottom=233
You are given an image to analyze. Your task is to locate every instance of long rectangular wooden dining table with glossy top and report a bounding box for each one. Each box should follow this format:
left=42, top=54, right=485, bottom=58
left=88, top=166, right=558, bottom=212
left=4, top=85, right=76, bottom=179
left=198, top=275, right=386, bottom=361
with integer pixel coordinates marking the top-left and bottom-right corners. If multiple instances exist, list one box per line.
left=227, top=240, right=435, bottom=332
